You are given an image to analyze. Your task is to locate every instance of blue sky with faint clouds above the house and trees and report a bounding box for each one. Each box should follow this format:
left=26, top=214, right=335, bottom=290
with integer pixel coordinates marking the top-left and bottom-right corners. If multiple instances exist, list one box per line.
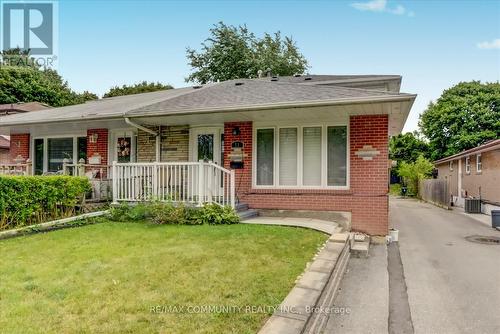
left=48, top=0, right=500, bottom=132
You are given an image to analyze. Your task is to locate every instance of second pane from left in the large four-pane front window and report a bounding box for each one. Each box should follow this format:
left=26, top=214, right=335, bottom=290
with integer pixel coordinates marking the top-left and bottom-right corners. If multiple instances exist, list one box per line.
left=279, top=128, right=297, bottom=186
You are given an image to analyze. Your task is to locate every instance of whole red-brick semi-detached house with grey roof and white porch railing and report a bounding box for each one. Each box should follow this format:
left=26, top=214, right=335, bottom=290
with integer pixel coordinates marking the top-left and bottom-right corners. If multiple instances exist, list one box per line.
left=0, top=75, right=416, bottom=235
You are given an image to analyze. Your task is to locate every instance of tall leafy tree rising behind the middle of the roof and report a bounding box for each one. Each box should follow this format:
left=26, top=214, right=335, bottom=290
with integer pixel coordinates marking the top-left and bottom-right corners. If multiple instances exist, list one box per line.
left=186, top=22, right=308, bottom=84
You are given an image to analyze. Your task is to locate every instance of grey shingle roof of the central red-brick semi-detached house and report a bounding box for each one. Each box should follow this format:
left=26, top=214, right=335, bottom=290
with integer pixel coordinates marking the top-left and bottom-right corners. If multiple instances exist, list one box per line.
left=0, top=75, right=413, bottom=127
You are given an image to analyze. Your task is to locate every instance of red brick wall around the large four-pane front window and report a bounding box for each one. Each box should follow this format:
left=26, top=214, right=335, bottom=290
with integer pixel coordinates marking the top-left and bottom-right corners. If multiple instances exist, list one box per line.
left=224, top=115, right=389, bottom=235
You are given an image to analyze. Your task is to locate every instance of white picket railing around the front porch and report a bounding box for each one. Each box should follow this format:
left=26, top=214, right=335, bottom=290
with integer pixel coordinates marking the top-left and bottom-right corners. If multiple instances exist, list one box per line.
left=112, top=161, right=235, bottom=208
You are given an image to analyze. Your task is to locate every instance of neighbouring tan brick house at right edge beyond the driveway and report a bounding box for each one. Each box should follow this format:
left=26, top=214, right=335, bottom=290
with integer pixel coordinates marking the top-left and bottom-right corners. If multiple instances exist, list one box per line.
left=434, top=139, right=500, bottom=215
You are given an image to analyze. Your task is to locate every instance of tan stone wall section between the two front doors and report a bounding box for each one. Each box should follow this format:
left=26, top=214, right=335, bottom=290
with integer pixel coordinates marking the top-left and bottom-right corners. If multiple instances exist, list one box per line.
left=137, top=125, right=189, bottom=162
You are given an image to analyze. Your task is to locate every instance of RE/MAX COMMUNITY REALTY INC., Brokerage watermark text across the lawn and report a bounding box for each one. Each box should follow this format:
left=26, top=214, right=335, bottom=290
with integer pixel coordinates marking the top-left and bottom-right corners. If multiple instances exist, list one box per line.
left=149, top=305, right=351, bottom=315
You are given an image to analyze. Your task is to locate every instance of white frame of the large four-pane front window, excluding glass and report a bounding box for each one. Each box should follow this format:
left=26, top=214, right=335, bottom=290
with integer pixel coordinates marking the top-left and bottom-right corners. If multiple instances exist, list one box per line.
left=252, top=121, right=351, bottom=190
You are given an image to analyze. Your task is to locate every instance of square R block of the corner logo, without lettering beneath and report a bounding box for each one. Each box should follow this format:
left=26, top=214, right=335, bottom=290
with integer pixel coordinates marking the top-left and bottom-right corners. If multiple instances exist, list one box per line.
left=2, top=2, right=54, bottom=55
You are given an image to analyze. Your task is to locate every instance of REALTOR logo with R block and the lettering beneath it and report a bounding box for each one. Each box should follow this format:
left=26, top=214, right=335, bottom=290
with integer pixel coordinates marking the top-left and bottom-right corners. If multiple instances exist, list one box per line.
left=0, top=0, right=58, bottom=68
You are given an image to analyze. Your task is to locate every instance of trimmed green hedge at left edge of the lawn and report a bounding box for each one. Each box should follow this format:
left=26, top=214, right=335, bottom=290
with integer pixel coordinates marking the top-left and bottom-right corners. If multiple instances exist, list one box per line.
left=0, top=175, right=91, bottom=230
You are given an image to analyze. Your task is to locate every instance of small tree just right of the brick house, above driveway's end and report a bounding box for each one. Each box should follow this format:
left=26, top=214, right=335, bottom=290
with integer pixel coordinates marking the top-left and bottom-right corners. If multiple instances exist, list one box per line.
left=389, top=131, right=429, bottom=163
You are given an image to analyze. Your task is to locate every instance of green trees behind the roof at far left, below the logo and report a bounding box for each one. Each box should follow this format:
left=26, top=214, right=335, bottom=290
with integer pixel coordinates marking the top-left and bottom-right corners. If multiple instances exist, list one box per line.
left=0, top=66, right=97, bottom=107
